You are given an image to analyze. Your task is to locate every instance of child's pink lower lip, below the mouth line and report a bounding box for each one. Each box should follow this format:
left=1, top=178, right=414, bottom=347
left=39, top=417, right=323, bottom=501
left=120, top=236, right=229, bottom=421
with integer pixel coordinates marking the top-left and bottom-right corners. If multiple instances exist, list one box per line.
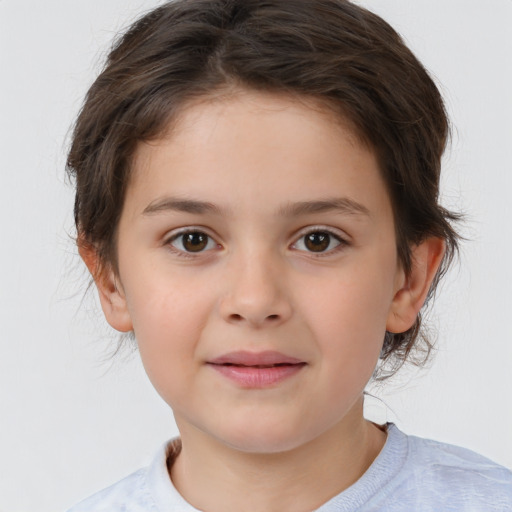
left=209, top=363, right=305, bottom=389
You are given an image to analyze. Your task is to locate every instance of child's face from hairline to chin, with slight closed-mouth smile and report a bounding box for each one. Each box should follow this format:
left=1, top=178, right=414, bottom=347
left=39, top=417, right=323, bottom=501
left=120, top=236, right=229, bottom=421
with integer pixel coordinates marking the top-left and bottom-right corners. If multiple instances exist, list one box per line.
left=105, top=92, right=405, bottom=452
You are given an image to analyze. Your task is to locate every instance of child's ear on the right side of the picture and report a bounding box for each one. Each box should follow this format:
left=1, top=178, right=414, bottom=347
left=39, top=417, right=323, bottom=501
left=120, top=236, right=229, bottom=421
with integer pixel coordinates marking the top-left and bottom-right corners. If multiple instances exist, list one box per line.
left=386, top=237, right=445, bottom=333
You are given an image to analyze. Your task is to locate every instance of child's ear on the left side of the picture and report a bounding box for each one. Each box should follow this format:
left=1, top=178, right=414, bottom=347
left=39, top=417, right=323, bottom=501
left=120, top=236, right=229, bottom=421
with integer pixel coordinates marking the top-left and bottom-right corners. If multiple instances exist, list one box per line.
left=78, top=238, right=133, bottom=332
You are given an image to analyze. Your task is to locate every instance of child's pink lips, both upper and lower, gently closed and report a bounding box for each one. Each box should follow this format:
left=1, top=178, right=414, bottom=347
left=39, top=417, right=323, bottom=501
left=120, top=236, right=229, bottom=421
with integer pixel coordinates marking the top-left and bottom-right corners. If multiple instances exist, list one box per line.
left=207, top=351, right=306, bottom=388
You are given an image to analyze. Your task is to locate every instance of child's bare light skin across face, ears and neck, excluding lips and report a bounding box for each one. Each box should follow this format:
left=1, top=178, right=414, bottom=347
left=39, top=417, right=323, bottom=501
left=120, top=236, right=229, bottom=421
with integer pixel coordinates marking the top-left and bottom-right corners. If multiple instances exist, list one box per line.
left=81, top=91, right=443, bottom=512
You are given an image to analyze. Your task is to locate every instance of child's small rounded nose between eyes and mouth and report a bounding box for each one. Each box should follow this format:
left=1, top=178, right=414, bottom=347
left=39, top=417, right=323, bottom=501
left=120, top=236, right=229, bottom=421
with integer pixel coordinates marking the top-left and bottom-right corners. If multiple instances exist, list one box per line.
left=220, top=249, right=292, bottom=328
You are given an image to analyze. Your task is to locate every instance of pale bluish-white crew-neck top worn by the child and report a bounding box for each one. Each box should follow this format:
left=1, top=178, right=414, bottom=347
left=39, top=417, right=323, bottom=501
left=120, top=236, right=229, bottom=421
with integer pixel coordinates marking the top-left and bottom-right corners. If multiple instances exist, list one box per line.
left=68, top=423, right=512, bottom=512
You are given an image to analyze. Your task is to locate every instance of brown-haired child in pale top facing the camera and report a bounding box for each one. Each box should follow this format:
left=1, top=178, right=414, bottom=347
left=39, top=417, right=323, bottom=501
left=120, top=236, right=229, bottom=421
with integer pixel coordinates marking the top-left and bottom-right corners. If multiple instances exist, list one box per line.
left=68, top=0, right=512, bottom=512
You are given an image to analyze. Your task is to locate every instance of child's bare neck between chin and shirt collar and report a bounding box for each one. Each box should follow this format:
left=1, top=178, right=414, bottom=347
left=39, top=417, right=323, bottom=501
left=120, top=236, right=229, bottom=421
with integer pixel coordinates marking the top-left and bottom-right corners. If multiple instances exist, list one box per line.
left=171, top=402, right=386, bottom=512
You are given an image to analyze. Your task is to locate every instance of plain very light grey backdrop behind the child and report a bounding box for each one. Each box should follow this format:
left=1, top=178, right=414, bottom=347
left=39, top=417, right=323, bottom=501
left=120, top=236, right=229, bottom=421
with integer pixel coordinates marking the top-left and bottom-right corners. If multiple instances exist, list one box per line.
left=0, top=0, right=512, bottom=512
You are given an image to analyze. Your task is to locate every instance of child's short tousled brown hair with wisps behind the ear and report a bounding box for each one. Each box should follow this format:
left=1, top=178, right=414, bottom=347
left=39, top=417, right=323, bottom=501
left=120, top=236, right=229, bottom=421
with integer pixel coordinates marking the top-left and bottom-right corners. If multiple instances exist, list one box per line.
left=67, top=0, right=458, bottom=373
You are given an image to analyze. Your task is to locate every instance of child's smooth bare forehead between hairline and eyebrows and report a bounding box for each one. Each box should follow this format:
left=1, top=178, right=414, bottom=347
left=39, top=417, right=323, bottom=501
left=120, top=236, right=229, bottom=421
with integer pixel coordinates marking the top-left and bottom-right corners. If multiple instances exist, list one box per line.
left=127, top=91, right=387, bottom=220
